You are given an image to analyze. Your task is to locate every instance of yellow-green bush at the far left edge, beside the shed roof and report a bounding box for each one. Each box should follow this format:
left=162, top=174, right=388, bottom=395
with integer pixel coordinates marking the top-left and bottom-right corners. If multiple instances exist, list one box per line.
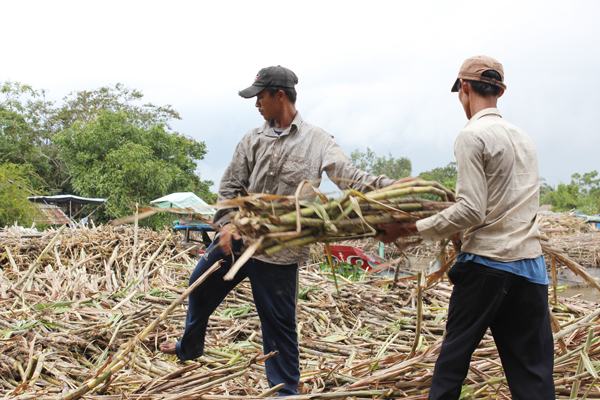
left=0, top=163, right=37, bottom=226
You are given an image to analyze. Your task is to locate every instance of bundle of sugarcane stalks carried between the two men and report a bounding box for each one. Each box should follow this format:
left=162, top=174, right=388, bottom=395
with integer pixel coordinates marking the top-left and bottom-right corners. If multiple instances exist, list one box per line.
left=218, top=178, right=454, bottom=266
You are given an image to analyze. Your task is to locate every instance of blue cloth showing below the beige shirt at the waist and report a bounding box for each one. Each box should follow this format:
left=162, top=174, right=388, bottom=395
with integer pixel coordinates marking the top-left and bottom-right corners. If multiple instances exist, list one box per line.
left=456, top=253, right=548, bottom=285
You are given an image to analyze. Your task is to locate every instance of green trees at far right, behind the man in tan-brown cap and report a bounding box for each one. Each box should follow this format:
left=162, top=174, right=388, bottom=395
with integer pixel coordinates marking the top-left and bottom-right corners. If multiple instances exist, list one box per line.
left=541, top=171, right=600, bottom=214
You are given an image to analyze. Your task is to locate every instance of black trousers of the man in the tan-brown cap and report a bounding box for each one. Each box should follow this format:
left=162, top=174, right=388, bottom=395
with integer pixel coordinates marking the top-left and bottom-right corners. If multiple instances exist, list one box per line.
left=429, top=262, right=555, bottom=400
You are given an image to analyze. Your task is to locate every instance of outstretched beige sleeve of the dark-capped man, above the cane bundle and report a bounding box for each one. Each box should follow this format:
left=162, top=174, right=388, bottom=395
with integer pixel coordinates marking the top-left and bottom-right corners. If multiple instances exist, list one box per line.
left=321, top=135, right=394, bottom=192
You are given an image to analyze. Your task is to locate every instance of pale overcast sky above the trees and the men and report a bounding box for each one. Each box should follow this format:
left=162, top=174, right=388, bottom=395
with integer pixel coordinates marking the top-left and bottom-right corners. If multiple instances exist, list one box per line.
left=0, top=0, right=600, bottom=194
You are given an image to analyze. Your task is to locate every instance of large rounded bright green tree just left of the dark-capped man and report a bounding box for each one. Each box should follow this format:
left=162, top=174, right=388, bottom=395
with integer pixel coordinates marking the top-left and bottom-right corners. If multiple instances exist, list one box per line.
left=55, top=111, right=212, bottom=218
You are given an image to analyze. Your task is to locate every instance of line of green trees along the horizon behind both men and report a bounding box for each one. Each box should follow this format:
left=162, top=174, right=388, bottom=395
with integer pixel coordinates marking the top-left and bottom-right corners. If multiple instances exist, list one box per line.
left=0, top=82, right=600, bottom=226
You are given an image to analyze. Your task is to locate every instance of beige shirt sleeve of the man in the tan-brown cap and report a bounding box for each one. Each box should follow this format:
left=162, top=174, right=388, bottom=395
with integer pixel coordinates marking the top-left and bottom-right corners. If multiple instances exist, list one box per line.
left=417, top=131, right=487, bottom=240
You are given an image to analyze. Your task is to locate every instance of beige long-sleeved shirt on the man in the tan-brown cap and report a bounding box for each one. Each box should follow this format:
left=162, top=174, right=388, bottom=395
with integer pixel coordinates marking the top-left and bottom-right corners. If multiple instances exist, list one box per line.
left=417, top=108, right=542, bottom=262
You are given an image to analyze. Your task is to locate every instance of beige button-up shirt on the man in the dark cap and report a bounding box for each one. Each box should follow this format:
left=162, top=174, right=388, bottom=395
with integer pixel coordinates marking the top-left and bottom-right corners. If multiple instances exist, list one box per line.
left=215, top=113, right=394, bottom=264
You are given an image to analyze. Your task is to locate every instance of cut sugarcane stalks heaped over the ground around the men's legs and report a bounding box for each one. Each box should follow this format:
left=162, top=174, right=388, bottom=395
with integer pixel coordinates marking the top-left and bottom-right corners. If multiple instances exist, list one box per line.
left=0, top=226, right=600, bottom=400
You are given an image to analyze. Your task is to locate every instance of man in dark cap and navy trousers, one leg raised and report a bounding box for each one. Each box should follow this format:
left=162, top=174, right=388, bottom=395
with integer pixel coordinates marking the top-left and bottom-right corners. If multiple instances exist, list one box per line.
left=161, top=66, right=394, bottom=395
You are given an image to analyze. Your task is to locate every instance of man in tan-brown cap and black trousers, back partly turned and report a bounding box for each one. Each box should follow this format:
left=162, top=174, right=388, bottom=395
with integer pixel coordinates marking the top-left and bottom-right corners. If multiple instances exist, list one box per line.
left=380, top=56, right=555, bottom=400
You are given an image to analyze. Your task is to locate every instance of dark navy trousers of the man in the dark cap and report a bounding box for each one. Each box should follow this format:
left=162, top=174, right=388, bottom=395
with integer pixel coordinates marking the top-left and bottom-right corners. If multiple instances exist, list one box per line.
left=177, top=241, right=300, bottom=395
